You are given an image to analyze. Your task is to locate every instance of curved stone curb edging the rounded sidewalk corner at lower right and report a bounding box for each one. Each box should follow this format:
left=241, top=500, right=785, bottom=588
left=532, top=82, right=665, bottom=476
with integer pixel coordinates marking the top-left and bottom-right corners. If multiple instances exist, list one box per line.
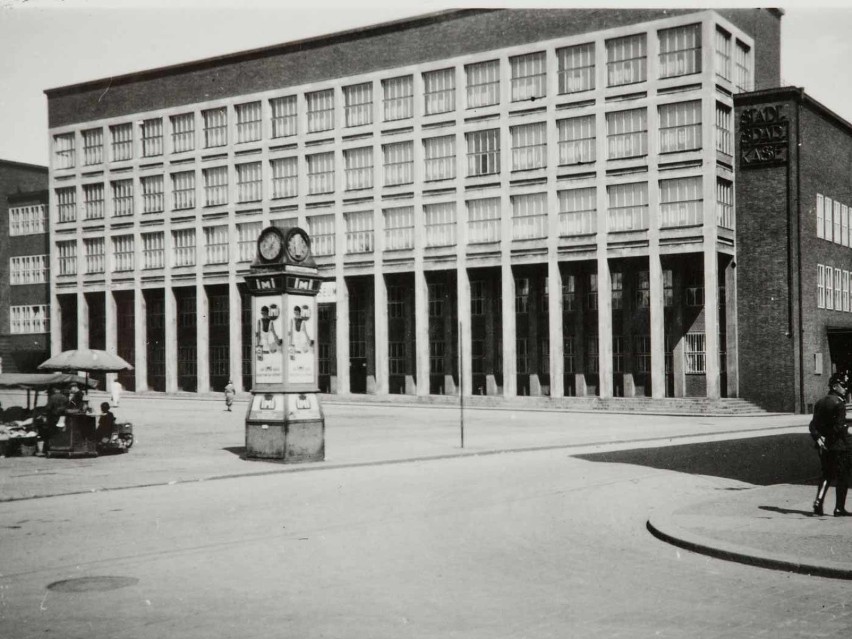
left=646, top=515, right=852, bottom=579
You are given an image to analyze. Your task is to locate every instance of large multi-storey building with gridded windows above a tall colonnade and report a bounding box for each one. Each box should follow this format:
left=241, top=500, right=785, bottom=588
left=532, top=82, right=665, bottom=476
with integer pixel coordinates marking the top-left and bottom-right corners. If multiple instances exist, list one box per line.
left=47, top=9, right=781, bottom=398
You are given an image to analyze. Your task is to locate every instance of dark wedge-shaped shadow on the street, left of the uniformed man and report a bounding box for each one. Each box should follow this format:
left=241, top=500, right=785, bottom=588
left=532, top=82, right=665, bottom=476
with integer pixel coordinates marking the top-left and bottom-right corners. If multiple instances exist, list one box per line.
left=574, top=433, right=819, bottom=486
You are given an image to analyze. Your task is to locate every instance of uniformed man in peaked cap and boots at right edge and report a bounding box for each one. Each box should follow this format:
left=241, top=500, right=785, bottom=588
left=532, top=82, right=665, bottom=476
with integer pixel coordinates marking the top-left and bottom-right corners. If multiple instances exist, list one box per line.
left=809, top=373, right=852, bottom=517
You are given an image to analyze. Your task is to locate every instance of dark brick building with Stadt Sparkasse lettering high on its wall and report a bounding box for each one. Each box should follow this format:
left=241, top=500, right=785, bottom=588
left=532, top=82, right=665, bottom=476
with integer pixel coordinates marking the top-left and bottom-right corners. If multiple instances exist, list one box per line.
left=734, top=87, right=852, bottom=412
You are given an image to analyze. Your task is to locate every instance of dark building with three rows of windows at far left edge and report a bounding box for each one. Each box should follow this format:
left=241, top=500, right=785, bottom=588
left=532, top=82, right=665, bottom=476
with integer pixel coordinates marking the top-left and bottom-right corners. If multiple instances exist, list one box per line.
left=0, top=160, right=50, bottom=373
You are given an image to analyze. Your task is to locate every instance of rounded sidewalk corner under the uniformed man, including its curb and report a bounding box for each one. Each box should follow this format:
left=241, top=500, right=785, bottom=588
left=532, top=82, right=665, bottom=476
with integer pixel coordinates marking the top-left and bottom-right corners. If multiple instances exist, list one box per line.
left=647, top=484, right=852, bottom=579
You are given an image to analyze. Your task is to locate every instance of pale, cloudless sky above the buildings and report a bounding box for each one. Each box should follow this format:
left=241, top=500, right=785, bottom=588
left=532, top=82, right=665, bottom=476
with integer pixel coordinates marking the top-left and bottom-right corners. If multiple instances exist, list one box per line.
left=0, top=0, right=852, bottom=165
